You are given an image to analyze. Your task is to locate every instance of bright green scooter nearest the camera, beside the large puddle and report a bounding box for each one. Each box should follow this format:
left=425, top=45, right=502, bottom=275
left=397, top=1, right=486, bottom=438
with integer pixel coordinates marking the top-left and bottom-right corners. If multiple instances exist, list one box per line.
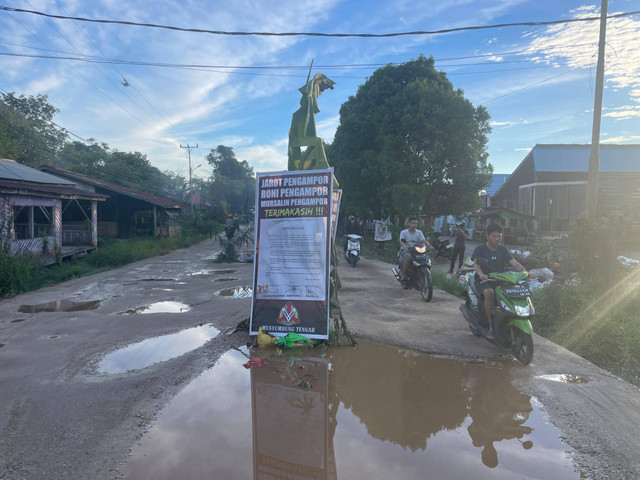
left=460, top=260, right=535, bottom=365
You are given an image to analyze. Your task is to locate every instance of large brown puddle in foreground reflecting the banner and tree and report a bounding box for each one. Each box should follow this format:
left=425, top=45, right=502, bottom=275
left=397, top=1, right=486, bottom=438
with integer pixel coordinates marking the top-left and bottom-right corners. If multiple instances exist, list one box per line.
left=123, top=342, right=580, bottom=480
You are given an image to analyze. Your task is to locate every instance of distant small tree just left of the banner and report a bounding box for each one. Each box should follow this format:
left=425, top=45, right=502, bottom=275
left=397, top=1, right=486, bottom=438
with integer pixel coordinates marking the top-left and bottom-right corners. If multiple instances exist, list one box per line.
left=206, top=145, right=255, bottom=213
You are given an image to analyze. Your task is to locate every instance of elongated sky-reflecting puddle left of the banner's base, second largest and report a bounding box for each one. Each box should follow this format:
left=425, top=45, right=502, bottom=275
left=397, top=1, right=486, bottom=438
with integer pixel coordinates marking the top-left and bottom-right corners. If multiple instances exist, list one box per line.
left=98, top=325, right=220, bottom=373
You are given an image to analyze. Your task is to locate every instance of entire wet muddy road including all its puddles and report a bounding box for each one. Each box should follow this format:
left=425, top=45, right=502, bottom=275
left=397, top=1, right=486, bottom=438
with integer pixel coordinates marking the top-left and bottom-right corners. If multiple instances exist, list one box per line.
left=0, top=242, right=640, bottom=479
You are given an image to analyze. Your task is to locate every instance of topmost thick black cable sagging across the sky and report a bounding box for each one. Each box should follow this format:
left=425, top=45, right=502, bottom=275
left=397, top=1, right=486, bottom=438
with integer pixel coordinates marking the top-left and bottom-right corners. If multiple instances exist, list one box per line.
left=0, top=5, right=640, bottom=38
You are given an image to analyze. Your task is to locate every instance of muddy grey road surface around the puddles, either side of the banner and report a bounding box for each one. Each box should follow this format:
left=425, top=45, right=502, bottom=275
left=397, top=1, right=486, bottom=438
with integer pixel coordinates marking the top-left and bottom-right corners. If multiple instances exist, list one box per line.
left=0, top=241, right=640, bottom=480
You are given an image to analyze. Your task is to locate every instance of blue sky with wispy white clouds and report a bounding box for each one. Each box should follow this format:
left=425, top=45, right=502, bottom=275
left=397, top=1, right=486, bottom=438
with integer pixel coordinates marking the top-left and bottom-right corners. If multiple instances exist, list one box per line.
left=0, top=0, right=640, bottom=177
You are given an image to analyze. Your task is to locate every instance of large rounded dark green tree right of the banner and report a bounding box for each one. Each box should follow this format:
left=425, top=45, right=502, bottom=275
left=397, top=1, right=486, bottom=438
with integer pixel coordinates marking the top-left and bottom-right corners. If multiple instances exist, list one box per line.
left=328, top=55, right=492, bottom=217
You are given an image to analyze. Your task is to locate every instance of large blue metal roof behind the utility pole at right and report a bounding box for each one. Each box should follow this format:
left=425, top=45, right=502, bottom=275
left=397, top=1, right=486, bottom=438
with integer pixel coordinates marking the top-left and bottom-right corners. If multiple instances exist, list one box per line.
left=532, top=145, right=640, bottom=172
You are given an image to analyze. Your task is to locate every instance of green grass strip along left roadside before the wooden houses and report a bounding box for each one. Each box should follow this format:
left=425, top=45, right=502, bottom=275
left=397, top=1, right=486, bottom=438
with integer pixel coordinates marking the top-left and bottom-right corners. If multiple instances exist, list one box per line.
left=0, top=235, right=215, bottom=298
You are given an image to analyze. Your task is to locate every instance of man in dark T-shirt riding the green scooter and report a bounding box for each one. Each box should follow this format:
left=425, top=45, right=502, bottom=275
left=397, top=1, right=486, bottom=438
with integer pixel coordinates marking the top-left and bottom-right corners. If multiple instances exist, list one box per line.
left=471, top=224, right=526, bottom=339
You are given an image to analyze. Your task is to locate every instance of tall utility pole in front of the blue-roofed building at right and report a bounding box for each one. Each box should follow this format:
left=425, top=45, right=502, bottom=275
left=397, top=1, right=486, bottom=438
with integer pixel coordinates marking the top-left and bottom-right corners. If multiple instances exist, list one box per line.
left=586, top=0, right=607, bottom=220
